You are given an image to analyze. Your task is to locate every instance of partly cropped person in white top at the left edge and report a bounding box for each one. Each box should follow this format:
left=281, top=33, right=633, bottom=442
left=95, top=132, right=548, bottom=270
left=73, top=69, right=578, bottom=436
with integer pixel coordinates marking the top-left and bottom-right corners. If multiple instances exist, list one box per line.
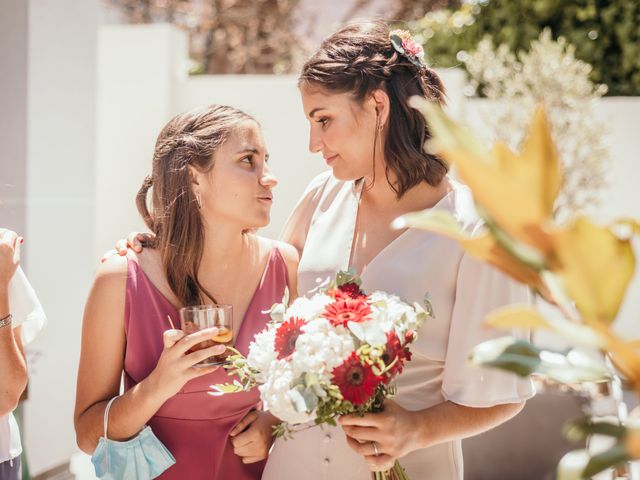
left=0, top=229, right=46, bottom=480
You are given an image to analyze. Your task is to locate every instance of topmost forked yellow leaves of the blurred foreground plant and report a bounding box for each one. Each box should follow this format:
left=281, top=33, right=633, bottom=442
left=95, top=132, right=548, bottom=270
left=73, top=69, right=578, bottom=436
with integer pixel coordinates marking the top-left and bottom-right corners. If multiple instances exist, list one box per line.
left=411, top=97, right=561, bottom=254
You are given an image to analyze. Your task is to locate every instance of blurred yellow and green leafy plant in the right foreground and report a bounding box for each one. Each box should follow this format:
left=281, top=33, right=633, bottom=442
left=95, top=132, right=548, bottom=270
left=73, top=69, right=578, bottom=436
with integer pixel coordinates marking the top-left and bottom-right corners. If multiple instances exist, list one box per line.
left=395, top=98, right=640, bottom=480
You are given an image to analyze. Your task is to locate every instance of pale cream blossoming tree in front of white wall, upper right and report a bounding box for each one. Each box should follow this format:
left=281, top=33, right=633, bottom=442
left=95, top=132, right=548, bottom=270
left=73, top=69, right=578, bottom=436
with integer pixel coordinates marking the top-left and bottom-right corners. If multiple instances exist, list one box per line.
left=460, top=29, right=609, bottom=219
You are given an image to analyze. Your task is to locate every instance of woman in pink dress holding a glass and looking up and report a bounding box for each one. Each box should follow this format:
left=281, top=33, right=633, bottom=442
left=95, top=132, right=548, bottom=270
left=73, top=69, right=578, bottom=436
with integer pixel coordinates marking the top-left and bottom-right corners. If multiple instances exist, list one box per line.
left=75, top=106, right=297, bottom=480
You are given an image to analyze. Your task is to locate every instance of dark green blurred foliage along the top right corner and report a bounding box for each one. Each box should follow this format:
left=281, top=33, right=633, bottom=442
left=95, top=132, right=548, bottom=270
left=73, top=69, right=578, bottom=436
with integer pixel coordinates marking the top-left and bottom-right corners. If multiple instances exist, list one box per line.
left=409, top=0, right=640, bottom=96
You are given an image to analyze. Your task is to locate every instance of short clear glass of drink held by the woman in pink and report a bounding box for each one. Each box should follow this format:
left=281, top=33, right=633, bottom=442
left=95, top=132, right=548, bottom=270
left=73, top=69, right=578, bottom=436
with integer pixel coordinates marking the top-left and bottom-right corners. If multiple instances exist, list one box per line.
left=180, top=305, right=233, bottom=367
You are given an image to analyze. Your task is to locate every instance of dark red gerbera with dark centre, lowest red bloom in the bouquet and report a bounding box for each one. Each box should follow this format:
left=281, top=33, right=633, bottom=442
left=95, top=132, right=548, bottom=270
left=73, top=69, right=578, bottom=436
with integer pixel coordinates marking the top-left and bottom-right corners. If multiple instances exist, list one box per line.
left=332, top=352, right=382, bottom=405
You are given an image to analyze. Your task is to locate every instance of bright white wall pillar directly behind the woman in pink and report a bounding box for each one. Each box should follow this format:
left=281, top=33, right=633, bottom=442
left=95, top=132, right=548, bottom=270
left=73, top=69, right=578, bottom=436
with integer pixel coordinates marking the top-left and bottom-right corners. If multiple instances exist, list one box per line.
left=93, top=25, right=187, bottom=258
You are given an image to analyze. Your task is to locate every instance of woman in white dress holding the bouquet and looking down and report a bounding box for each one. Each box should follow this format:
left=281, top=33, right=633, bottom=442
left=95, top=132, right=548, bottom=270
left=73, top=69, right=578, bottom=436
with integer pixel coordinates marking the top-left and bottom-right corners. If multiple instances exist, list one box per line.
left=263, top=21, right=534, bottom=480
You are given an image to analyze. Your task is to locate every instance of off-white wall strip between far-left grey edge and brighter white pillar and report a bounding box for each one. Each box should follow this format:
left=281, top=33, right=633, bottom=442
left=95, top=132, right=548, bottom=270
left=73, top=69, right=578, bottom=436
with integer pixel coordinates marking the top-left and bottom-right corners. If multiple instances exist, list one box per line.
left=23, top=0, right=98, bottom=474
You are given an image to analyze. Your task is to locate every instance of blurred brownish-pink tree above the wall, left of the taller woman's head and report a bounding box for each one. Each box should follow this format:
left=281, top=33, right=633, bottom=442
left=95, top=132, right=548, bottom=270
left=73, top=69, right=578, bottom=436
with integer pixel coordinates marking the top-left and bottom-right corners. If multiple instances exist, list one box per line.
left=105, top=0, right=305, bottom=73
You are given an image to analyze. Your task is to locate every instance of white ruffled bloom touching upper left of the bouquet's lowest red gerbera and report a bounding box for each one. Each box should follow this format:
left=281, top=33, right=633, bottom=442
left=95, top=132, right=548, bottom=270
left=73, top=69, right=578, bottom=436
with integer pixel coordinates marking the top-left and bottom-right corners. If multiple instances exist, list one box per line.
left=291, top=318, right=355, bottom=383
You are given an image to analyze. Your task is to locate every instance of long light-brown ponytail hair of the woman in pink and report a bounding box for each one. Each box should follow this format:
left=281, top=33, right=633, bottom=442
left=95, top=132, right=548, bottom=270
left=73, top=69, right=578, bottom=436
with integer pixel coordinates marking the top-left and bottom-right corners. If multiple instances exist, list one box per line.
left=136, top=105, right=255, bottom=306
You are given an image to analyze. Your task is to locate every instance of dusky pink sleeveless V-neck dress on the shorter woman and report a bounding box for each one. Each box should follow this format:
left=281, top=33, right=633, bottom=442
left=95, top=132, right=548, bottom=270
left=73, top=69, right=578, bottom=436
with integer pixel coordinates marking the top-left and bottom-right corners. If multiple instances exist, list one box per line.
left=124, top=248, right=288, bottom=480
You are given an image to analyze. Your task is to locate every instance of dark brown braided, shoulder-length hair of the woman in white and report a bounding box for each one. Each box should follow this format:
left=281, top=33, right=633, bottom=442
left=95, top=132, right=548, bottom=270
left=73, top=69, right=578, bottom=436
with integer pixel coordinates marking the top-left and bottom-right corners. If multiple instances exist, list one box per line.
left=298, top=20, right=448, bottom=198
